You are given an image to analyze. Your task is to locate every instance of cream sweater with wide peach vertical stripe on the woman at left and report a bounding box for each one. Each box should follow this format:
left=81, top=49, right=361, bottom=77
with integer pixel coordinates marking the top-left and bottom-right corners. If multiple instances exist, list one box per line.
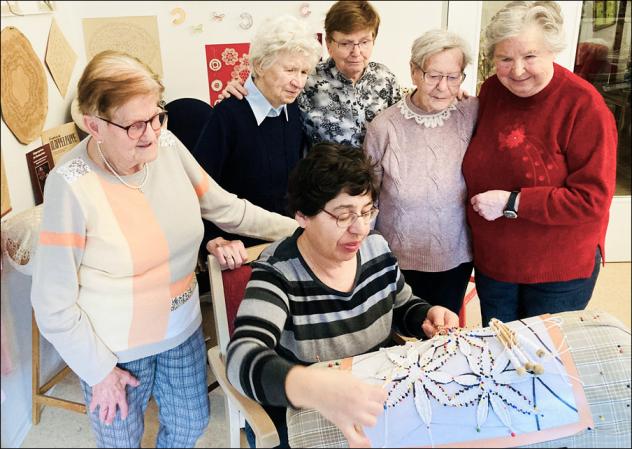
left=31, top=131, right=296, bottom=385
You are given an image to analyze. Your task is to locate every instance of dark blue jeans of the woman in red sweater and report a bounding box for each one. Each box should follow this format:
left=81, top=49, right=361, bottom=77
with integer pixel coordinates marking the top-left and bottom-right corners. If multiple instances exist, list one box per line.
left=475, top=250, right=601, bottom=326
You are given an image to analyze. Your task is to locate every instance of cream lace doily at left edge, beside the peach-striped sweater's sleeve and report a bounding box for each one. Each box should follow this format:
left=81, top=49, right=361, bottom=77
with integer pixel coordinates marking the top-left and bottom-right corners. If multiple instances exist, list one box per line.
left=2, top=204, right=43, bottom=276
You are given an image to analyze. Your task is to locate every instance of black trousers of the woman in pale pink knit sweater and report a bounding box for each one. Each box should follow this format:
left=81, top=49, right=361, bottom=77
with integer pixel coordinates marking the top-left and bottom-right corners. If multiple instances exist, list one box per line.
left=402, top=262, right=473, bottom=314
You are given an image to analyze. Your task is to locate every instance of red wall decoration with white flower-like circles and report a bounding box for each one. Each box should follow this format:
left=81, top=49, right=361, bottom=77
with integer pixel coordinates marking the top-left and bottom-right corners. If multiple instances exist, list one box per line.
left=206, top=43, right=250, bottom=106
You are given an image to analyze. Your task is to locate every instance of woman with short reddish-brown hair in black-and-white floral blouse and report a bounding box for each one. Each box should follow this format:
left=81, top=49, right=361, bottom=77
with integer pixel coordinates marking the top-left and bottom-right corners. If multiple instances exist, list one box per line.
left=222, top=0, right=401, bottom=146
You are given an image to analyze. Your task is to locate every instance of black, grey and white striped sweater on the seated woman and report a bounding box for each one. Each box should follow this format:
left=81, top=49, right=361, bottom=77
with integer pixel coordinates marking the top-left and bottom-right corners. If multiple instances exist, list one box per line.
left=227, top=229, right=431, bottom=407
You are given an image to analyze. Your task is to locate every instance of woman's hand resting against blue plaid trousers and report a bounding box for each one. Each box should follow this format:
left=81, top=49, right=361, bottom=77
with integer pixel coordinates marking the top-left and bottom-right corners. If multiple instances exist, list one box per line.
left=90, top=366, right=140, bottom=425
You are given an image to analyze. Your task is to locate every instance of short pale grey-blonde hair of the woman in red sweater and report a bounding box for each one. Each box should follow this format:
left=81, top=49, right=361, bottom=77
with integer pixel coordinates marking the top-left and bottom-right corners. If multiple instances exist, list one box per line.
left=485, top=1, right=566, bottom=58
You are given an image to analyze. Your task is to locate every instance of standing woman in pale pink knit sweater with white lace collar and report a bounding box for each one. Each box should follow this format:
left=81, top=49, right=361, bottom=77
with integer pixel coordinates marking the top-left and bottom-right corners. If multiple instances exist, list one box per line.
left=364, top=30, right=478, bottom=313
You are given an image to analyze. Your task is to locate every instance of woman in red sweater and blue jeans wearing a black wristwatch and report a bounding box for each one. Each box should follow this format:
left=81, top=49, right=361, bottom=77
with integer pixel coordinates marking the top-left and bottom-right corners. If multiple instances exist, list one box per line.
left=463, top=1, right=617, bottom=323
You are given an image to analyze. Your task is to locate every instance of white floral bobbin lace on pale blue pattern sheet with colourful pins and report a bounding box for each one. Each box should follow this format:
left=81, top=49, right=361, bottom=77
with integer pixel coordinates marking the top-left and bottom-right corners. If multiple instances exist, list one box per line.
left=352, top=318, right=578, bottom=447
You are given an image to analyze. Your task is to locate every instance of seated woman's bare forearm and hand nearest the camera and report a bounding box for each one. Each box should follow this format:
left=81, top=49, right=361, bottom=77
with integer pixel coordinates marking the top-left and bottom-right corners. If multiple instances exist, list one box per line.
left=285, top=366, right=387, bottom=447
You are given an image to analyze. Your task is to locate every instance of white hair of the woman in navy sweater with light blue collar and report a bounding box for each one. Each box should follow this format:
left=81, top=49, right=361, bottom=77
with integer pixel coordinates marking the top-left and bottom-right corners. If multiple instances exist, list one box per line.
left=250, top=14, right=322, bottom=74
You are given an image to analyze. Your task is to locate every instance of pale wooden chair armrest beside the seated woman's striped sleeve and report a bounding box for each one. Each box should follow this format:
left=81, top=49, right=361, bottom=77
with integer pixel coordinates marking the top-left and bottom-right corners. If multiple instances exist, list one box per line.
left=208, top=346, right=280, bottom=447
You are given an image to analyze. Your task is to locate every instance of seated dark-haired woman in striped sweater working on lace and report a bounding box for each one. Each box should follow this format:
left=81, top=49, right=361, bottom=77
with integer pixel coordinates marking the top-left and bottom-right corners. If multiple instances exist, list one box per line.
left=227, top=143, right=458, bottom=447
